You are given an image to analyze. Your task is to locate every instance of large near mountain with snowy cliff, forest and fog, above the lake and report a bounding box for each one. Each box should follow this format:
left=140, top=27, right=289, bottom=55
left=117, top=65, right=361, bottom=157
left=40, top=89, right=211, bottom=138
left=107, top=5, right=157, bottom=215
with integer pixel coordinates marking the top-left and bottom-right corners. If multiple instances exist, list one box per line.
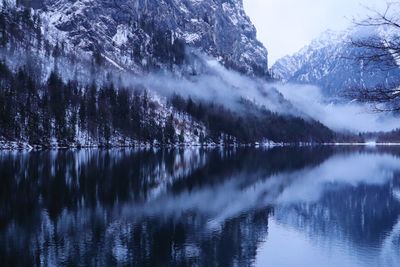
left=0, top=0, right=344, bottom=148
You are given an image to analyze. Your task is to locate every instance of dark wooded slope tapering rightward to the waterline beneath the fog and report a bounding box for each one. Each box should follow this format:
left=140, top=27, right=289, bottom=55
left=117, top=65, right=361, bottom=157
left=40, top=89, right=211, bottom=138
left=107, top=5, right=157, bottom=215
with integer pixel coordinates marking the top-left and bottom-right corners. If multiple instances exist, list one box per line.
left=167, top=95, right=337, bottom=144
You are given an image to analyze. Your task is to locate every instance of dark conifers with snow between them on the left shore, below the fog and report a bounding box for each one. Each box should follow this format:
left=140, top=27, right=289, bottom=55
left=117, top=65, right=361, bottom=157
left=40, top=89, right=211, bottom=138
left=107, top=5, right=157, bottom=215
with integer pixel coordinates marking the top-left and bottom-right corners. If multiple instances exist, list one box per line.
left=0, top=62, right=181, bottom=146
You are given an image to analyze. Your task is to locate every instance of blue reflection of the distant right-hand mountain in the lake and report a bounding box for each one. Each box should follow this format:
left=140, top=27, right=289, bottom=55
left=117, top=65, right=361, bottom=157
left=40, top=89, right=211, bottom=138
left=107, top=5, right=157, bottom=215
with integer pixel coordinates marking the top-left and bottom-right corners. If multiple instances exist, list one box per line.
left=275, top=173, right=400, bottom=266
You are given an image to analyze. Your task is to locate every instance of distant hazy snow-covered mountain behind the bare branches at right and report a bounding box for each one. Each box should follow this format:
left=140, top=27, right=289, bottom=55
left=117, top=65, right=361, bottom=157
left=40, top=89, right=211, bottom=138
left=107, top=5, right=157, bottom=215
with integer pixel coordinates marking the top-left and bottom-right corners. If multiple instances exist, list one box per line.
left=271, top=29, right=400, bottom=97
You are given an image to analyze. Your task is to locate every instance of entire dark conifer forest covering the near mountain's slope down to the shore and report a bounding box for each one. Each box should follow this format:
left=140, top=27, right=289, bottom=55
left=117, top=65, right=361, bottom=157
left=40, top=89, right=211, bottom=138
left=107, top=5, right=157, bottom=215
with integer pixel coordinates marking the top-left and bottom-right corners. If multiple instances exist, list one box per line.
left=0, top=4, right=357, bottom=147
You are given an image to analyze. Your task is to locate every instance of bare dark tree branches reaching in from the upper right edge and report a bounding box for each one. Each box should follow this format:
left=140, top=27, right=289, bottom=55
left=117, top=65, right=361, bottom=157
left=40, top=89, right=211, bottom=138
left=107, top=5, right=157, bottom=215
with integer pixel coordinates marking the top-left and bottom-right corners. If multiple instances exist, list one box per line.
left=350, top=0, right=400, bottom=111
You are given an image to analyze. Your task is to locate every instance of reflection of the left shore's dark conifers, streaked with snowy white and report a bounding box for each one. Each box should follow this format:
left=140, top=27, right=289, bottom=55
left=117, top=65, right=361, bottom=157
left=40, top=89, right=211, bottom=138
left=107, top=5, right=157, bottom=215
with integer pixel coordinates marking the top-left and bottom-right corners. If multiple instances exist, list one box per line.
left=0, top=150, right=205, bottom=225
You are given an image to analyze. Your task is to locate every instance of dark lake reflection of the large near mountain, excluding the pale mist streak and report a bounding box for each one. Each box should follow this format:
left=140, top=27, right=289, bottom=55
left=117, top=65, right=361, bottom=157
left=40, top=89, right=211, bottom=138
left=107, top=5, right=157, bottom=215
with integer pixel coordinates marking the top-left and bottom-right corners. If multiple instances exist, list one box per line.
left=0, top=148, right=388, bottom=266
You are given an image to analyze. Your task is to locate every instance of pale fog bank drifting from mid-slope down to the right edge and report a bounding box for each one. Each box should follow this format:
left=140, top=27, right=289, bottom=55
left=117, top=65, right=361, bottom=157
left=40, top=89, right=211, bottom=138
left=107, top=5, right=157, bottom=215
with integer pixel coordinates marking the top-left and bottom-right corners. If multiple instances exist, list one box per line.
left=123, top=59, right=400, bottom=133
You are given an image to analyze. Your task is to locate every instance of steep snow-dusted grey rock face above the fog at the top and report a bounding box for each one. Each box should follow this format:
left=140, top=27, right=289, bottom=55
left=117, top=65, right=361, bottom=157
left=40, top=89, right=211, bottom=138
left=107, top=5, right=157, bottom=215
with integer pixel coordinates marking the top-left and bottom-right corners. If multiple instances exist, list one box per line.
left=32, top=0, right=268, bottom=76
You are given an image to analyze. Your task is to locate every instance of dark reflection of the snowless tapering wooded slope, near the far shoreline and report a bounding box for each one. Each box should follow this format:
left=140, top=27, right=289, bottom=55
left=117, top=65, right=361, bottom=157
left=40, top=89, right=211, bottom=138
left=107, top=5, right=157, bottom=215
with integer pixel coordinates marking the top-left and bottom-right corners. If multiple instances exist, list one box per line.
left=172, top=147, right=333, bottom=195
